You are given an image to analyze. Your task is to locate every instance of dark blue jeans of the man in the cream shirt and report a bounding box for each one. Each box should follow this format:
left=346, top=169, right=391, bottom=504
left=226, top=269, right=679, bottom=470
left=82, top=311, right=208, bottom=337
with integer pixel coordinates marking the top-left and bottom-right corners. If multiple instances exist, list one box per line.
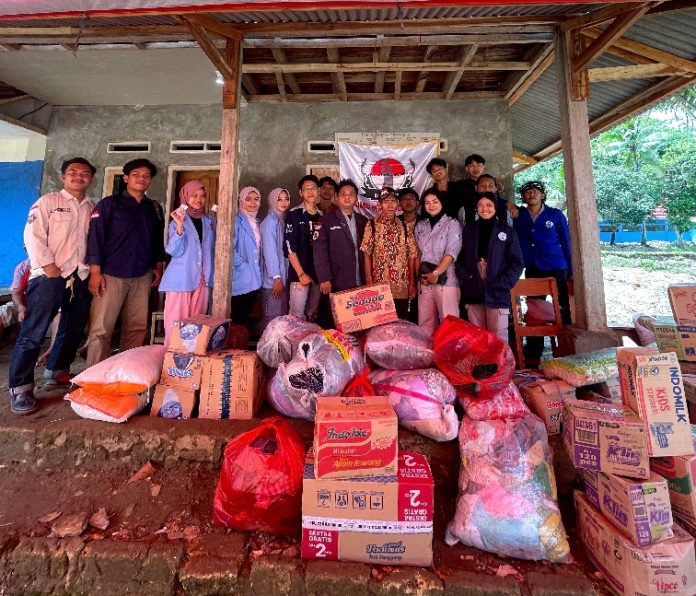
left=10, top=273, right=92, bottom=393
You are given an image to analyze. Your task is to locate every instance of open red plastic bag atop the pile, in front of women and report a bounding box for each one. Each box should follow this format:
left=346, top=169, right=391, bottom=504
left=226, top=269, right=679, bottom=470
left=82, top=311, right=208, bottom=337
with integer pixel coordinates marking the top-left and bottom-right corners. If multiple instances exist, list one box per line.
left=433, top=315, right=515, bottom=399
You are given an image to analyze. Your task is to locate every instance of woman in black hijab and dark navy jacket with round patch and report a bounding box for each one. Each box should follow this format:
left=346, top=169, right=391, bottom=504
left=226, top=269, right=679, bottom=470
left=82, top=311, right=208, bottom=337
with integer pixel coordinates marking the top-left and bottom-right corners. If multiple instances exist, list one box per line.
left=456, top=192, right=524, bottom=341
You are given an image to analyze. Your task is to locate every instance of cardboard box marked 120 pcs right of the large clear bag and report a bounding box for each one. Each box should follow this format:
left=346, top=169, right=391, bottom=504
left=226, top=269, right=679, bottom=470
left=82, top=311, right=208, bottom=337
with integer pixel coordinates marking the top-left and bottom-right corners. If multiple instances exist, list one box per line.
left=563, top=399, right=650, bottom=480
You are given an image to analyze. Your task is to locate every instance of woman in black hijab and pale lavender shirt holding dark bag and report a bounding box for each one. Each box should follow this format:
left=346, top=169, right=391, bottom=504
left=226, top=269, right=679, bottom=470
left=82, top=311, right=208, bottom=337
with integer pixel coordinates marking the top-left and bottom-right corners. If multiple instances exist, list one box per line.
left=414, top=189, right=462, bottom=335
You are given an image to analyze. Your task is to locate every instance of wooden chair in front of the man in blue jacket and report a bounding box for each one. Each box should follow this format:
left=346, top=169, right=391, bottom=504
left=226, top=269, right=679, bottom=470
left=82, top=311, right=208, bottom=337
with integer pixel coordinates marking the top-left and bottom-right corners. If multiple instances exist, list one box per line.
left=510, top=277, right=563, bottom=368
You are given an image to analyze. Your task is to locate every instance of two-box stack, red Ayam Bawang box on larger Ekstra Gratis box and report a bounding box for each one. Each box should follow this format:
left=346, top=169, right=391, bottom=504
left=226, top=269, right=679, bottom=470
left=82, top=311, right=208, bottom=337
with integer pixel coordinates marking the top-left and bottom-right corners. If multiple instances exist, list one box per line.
left=302, top=397, right=434, bottom=566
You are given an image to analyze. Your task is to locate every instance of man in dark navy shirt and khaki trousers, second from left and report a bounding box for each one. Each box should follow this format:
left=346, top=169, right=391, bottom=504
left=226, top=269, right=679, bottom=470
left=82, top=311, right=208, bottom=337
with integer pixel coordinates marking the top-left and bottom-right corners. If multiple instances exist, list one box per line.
left=87, top=159, right=165, bottom=366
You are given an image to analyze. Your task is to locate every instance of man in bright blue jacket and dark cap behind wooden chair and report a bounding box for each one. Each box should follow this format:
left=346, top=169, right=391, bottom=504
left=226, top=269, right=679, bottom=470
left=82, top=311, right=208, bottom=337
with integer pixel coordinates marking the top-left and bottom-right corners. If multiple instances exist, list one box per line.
left=514, top=180, right=573, bottom=363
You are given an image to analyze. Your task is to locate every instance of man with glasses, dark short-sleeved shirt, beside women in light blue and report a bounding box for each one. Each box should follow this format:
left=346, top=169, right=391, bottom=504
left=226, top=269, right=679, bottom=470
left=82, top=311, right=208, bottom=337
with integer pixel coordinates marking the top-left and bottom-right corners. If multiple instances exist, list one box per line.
left=284, top=174, right=322, bottom=321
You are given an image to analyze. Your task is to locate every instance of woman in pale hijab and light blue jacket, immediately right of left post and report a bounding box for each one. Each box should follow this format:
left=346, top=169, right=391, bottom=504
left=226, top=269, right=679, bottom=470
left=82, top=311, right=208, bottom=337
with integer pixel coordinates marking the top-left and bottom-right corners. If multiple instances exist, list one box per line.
left=260, top=188, right=290, bottom=332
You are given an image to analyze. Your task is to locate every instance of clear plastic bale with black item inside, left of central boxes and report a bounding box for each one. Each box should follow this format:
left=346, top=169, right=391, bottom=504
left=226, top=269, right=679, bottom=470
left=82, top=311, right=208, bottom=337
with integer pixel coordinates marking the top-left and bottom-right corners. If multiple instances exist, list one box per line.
left=276, top=329, right=365, bottom=416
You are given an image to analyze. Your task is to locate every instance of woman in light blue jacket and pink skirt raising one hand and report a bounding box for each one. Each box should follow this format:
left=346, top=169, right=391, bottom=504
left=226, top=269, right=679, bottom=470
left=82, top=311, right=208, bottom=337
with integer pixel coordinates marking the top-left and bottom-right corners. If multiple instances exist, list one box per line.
left=159, top=180, right=215, bottom=347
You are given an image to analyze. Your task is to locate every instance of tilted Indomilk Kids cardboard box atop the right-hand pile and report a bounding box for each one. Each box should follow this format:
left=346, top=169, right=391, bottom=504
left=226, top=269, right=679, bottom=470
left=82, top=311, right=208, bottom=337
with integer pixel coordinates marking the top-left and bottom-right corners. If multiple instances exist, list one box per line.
left=616, top=348, right=694, bottom=457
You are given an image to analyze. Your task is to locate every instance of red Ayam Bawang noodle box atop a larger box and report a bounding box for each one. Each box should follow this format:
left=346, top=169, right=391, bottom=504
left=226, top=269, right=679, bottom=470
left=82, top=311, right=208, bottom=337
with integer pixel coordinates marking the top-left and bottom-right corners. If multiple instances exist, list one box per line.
left=313, top=396, right=399, bottom=478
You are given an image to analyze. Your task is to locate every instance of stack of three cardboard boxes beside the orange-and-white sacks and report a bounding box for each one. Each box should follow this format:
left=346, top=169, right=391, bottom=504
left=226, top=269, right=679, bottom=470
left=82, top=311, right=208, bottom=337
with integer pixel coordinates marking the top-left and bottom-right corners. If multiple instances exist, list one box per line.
left=151, top=315, right=263, bottom=419
